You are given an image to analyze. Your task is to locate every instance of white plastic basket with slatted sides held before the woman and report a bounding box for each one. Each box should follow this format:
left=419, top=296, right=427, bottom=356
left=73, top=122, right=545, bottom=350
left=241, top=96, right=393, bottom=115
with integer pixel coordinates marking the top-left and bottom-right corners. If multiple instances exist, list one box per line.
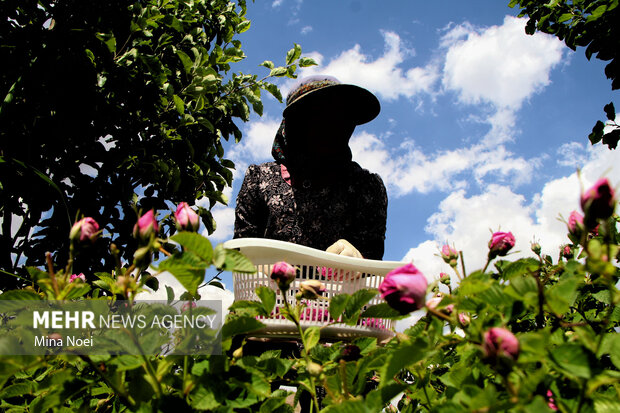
left=224, top=238, right=406, bottom=340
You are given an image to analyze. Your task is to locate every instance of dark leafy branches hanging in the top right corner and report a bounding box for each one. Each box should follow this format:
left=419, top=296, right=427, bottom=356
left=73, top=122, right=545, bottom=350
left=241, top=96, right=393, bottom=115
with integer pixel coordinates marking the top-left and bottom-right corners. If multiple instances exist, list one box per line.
left=509, top=0, right=620, bottom=149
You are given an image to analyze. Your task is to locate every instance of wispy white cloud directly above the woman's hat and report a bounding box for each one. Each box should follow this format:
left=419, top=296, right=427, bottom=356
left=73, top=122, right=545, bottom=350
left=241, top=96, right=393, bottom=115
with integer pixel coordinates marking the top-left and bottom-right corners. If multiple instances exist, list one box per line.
left=296, top=31, right=439, bottom=100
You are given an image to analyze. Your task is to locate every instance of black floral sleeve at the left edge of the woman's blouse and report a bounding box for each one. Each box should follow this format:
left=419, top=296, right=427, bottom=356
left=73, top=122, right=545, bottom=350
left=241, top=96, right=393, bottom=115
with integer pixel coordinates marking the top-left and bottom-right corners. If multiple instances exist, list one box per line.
left=233, top=165, right=266, bottom=238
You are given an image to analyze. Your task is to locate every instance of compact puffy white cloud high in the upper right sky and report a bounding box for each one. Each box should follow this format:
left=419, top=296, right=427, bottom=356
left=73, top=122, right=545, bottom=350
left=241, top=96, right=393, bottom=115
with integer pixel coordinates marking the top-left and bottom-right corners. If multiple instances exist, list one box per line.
left=442, top=16, right=565, bottom=109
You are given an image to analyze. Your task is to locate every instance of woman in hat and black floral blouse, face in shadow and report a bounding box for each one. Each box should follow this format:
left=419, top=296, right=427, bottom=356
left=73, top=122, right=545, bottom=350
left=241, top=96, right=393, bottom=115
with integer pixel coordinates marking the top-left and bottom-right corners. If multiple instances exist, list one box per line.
left=234, top=76, right=387, bottom=259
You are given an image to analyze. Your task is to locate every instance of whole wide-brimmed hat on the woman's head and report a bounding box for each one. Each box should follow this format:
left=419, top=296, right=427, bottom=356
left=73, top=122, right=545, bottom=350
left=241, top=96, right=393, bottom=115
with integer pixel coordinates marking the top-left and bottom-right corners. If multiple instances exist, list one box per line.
left=283, top=75, right=381, bottom=125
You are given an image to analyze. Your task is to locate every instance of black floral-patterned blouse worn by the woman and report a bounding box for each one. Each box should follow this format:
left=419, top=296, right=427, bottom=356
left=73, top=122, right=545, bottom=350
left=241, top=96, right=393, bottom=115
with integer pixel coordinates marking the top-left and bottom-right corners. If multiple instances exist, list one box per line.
left=234, top=162, right=387, bottom=259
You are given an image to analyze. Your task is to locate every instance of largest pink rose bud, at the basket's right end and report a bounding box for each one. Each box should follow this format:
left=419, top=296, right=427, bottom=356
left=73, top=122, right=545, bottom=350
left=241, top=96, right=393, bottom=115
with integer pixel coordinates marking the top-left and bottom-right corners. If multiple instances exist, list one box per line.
left=379, top=264, right=428, bottom=315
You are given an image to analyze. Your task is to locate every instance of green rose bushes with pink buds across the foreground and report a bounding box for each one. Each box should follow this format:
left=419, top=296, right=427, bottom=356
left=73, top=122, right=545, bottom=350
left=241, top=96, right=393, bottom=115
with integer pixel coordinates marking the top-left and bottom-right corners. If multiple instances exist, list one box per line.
left=0, top=180, right=620, bottom=413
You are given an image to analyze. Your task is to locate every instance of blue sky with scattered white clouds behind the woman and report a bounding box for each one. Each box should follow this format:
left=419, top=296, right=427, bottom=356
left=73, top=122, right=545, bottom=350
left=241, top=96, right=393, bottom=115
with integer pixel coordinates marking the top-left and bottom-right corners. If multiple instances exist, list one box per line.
left=154, top=0, right=620, bottom=302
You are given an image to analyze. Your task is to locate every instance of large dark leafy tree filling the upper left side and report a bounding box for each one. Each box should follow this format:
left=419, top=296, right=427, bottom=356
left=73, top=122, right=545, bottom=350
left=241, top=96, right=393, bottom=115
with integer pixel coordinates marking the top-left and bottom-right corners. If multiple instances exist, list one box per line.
left=0, top=0, right=314, bottom=290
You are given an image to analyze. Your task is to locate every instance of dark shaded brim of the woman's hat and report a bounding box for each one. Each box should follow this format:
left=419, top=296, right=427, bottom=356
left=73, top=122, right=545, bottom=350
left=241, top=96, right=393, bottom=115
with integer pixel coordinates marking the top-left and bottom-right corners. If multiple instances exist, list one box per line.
left=283, top=83, right=381, bottom=125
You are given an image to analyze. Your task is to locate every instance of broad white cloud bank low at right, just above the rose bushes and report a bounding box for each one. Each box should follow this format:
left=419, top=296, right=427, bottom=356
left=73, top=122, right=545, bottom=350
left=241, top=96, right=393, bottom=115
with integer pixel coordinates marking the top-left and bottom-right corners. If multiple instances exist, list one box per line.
left=403, top=146, right=620, bottom=276
